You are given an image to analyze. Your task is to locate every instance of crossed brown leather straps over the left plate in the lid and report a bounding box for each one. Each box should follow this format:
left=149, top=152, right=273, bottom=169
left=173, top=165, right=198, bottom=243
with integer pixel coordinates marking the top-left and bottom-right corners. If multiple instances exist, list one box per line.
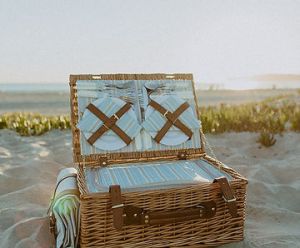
left=87, top=103, right=132, bottom=145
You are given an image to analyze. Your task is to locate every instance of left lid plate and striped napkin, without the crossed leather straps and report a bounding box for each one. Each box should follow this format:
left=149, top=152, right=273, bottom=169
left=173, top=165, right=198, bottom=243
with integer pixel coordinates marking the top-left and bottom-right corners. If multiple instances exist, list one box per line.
left=77, top=97, right=142, bottom=150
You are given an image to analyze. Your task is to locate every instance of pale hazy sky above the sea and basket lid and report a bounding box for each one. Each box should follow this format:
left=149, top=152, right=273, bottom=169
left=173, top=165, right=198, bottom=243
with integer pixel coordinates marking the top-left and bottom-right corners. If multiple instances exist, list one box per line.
left=0, top=0, right=300, bottom=87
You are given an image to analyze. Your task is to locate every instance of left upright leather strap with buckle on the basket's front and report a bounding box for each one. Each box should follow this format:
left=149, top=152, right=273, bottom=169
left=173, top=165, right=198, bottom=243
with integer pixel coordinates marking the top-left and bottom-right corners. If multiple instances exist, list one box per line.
left=109, top=185, right=124, bottom=230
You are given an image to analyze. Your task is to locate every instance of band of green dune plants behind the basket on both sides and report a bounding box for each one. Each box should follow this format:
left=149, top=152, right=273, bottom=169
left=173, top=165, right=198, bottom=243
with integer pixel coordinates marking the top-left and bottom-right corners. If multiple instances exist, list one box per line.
left=0, top=95, right=300, bottom=136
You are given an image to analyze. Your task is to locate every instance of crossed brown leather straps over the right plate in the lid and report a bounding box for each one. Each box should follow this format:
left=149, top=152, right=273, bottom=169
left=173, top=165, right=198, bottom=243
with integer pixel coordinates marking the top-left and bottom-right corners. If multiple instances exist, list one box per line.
left=149, top=100, right=193, bottom=143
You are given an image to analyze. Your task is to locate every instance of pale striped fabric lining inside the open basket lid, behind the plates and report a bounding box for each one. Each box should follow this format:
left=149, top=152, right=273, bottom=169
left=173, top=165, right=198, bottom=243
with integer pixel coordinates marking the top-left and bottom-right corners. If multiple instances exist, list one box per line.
left=77, top=80, right=202, bottom=155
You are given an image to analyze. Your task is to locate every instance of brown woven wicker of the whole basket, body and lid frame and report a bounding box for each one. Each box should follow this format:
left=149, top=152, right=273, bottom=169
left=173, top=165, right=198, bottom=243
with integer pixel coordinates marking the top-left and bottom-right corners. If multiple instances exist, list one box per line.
left=70, top=74, right=247, bottom=248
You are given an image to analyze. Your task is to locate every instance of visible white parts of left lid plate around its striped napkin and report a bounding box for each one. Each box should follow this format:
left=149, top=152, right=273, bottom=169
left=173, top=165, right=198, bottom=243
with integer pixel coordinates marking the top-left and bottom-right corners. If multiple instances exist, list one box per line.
left=82, top=97, right=137, bottom=151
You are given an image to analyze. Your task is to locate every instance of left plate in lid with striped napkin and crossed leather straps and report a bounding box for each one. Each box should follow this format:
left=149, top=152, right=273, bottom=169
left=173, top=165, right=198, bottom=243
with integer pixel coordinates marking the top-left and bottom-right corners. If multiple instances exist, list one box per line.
left=77, top=97, right=142, bottom=152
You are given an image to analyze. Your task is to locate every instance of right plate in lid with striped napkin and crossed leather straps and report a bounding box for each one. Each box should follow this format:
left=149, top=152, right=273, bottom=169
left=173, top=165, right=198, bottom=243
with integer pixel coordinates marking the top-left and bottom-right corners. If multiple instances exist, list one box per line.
left=142, top=94, right=200, bottom=146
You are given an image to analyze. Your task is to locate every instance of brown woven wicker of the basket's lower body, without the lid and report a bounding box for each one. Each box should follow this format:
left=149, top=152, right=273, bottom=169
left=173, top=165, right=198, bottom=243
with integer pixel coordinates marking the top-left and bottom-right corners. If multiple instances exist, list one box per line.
left=79, top=157, right=247, bottom=247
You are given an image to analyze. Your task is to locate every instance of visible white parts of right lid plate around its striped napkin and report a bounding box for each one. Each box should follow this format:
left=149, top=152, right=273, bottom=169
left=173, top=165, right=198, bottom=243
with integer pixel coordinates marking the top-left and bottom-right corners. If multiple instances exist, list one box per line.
left=145, top=95, right=194, bottom=146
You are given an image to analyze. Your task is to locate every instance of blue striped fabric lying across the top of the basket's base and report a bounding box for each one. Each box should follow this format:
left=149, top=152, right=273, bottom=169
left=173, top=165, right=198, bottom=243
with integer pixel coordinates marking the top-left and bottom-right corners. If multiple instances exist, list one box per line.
left=85, top=159, right=232, bottom=193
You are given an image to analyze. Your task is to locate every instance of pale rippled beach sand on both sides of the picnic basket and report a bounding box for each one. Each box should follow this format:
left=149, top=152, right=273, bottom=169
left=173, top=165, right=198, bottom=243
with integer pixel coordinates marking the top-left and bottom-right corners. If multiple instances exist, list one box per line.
left=0, top=130, right=300, bottom=248
